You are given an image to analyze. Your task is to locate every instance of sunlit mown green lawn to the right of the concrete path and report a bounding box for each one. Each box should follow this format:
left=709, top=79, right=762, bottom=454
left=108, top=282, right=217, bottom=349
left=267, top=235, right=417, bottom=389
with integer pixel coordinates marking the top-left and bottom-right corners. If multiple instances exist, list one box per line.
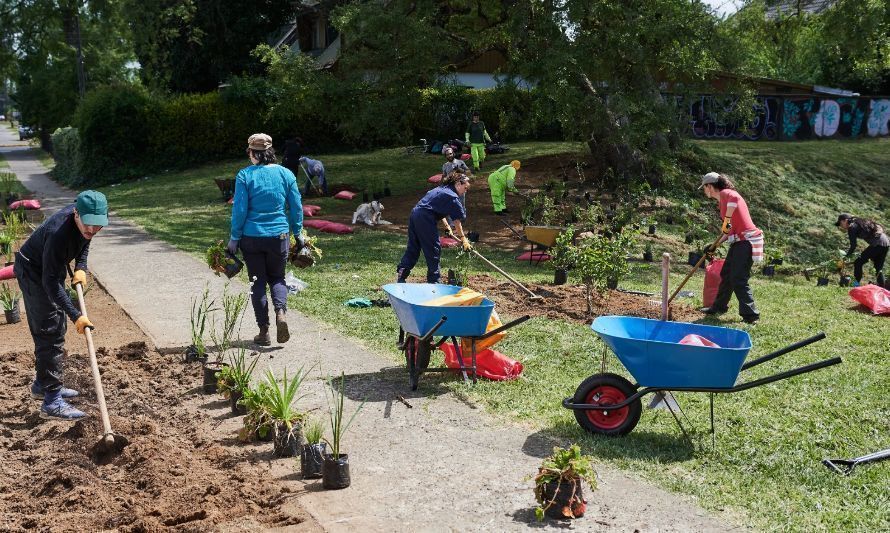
left=104, top=141, right=890, bottom=531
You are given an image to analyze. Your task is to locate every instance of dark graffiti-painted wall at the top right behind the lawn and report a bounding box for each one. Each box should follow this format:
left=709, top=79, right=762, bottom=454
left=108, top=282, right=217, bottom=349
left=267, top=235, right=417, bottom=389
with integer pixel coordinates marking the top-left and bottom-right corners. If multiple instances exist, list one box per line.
left=677, top=95, right=890, bottom=141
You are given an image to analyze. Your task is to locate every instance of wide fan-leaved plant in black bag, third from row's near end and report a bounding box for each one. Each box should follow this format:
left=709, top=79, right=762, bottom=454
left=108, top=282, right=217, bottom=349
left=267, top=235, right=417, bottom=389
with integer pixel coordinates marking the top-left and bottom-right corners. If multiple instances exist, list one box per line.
left=264, top=366, right=311, bottom=457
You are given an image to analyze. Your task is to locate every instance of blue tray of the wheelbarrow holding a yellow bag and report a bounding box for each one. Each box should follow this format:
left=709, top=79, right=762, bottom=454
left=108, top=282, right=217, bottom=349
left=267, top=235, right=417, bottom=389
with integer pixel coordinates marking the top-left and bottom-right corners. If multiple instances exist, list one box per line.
left=383, top=283, right=494, bottom=337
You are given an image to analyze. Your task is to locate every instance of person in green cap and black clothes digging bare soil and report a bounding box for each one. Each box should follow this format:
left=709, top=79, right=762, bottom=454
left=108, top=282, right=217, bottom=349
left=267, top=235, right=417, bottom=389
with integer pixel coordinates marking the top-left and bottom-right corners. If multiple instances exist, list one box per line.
left=13, top=191, right=108, bottom=420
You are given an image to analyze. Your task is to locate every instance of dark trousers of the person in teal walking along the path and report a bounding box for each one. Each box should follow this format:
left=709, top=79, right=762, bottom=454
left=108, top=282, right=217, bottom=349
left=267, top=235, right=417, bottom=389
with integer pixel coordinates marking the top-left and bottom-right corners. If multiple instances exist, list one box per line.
left=238, top=233, right=290, bottom=327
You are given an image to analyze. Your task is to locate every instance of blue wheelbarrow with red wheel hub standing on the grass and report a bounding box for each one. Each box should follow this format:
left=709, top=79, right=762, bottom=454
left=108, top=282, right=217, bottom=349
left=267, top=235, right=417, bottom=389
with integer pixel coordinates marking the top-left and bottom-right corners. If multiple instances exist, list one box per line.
left=562, top=316, right=841, bottom=437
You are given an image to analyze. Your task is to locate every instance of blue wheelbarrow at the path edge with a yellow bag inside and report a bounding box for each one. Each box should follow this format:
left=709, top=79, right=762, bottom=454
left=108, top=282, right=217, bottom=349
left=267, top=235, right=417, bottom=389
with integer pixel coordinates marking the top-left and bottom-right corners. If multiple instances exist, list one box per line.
left=383, top=283, right=529, bottom=390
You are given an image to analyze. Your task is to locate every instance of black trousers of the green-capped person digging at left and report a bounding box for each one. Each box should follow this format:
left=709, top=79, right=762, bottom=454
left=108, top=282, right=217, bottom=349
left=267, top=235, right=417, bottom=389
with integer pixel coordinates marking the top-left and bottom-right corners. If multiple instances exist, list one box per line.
left=13, top=254, right=68, bottom=396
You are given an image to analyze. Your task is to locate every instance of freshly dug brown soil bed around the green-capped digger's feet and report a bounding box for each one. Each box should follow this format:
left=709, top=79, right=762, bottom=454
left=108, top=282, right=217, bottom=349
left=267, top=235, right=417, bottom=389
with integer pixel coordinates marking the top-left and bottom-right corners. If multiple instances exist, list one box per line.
left=0, top=341, right=308, bottom=531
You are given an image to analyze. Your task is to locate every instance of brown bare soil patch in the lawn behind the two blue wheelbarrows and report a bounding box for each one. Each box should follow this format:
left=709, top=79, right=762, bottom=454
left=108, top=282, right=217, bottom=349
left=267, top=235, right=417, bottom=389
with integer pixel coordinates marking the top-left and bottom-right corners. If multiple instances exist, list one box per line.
left=468, top=274, right=704, bottom=324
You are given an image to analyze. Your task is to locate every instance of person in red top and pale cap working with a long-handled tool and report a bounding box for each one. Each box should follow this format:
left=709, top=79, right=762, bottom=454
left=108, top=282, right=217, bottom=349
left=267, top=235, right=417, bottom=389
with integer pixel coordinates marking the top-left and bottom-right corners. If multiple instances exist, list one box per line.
left=699, top=172, right=763, bottom=324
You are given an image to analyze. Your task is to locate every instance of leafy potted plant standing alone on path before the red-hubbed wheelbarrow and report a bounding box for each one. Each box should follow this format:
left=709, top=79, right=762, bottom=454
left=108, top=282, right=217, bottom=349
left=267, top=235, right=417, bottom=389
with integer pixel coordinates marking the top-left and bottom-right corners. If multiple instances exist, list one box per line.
left=535, top=444, right=596, bottom=520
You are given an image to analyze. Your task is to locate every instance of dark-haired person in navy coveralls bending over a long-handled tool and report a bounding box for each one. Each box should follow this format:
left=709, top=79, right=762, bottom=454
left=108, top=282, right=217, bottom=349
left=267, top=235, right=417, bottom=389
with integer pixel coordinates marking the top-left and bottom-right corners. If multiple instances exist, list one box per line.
left=396, top=172, right=470, bottom=283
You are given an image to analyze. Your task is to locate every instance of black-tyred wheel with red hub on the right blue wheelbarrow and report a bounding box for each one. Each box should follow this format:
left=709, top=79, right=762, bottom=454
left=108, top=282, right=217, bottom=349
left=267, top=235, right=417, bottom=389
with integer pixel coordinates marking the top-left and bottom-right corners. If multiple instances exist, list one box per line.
left=573, top=374, right=643, bottom=436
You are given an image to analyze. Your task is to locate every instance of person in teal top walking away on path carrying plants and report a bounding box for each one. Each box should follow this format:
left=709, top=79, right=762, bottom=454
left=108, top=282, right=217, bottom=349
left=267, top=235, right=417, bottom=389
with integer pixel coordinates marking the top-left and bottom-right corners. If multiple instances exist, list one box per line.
left=228, top=133, right=306, bottom=346
